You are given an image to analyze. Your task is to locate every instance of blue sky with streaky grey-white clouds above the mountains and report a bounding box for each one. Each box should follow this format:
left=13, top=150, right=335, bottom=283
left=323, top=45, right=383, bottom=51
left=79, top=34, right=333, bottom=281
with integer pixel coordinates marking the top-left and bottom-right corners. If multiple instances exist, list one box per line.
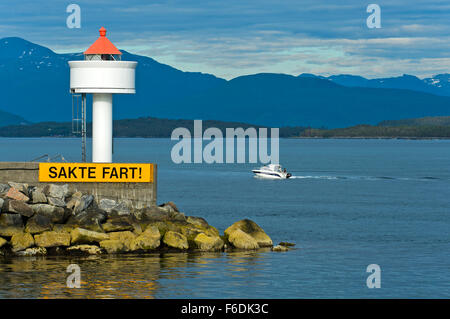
left=0, top=0, right=450, bottom=79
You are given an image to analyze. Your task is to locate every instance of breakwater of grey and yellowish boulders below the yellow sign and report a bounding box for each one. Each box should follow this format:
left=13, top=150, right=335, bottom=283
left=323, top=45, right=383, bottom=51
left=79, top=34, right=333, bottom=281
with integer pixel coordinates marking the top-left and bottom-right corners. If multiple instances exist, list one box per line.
left=0, top=182, right=288, bottom=256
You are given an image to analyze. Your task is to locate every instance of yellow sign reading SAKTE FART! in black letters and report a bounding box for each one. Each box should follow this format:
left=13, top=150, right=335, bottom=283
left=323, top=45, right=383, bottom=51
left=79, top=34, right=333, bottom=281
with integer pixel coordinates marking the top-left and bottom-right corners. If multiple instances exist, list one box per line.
left=39, top=163, right=153, bottom=183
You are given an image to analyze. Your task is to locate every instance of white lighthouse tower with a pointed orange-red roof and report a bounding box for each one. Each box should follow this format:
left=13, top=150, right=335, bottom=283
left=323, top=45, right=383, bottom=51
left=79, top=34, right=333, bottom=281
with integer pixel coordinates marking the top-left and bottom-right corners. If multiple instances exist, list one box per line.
left=69, top=27, right=137, bottom=163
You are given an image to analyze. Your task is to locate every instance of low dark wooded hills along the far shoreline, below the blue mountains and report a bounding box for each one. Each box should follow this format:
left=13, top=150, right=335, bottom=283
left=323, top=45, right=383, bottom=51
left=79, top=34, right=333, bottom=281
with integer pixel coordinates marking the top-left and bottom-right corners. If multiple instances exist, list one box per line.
left=0, top=116, right=450, bottom=138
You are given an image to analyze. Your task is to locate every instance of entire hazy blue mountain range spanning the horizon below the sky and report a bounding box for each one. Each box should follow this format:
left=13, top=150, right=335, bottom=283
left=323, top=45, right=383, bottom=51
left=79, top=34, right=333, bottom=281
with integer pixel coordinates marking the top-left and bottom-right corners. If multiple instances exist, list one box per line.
left=0, top=38, right=450, bottom=127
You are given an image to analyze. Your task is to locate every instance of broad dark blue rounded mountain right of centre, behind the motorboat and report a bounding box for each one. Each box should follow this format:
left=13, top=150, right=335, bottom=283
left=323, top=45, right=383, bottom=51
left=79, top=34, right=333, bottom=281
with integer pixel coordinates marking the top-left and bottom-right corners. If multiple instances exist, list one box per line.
left=153, top=74, right=450, bottom=127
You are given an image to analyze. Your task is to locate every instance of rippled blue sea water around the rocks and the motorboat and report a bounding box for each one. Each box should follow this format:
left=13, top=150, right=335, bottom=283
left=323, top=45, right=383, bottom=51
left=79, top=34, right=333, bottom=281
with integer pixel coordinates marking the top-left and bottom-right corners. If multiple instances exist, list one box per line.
left=0, top=138, right=450, bottom=298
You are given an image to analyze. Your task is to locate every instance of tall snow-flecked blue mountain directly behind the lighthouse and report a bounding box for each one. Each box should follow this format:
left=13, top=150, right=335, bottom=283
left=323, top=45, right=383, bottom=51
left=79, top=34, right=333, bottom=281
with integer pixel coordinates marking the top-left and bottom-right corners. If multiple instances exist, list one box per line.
left=0, top=38, right=226, bottom=122
